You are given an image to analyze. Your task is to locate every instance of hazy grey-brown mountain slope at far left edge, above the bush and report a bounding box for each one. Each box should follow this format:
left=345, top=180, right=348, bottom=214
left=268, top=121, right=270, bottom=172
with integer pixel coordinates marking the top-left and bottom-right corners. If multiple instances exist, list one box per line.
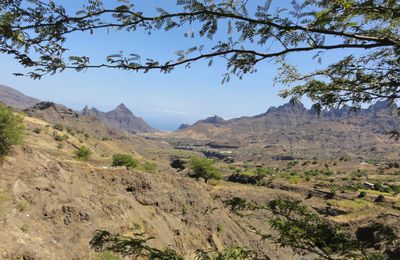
left=0, top=85, right=40, bottom=110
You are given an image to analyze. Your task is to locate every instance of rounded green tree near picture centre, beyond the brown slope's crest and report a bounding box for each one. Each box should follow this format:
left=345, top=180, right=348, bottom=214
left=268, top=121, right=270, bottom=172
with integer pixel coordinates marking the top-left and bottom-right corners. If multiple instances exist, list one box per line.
left=189, top=157, right=222, bottom=183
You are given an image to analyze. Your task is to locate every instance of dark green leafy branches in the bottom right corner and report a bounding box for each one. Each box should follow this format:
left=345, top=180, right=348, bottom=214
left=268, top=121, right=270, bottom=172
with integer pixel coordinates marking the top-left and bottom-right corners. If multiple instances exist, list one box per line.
left=224, top=197, right=399, bottom=260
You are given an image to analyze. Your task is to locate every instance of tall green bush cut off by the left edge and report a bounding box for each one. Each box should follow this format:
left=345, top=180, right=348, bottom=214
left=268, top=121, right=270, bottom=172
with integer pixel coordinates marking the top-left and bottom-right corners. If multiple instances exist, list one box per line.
left=0, top=104, right=25, bottom=157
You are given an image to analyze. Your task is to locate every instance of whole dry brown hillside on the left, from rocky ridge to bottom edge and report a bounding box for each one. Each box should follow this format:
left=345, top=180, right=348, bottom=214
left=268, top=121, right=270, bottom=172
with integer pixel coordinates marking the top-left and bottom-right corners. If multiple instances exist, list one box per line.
left=0, top=109, right=304, bottom=260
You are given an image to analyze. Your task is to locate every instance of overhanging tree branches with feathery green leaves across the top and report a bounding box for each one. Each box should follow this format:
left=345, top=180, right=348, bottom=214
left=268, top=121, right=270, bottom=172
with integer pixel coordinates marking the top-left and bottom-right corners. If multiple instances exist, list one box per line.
left=0, top=0, right=400, bottom=110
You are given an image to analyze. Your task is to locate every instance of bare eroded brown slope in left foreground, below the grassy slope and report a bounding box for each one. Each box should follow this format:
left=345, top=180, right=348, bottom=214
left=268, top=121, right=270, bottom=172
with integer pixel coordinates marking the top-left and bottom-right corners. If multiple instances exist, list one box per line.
left=0, top=148, right=296, bottom=259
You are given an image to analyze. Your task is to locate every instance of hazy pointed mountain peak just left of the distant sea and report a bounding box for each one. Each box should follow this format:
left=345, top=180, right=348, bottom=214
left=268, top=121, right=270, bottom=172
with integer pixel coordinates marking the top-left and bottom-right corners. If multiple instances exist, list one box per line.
left=81, top=104, right=156, bottom=133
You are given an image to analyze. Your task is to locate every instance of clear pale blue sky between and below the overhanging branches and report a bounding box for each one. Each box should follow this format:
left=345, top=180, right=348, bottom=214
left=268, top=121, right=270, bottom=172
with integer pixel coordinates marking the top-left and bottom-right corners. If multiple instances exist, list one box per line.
left=0, top=0, right=360, bottom=131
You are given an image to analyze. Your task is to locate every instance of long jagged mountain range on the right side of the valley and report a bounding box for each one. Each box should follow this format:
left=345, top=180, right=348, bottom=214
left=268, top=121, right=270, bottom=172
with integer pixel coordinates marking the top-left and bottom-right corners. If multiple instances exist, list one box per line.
left=172, top=101, right=400, bottom=158
